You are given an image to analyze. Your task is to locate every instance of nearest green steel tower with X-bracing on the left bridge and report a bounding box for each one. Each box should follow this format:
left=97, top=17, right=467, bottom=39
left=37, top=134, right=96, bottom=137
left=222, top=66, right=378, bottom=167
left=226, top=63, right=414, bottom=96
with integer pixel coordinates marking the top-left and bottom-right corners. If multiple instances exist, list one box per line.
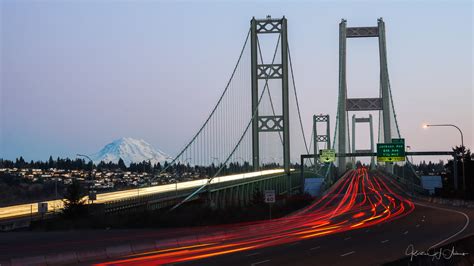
left=250, top=17, right=290, bottom=174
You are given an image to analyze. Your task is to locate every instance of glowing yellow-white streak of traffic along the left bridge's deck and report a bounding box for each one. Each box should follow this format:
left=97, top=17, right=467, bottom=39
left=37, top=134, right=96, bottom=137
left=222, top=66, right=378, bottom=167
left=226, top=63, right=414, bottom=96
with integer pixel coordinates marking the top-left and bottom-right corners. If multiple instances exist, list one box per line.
left=0, top=169, right=284, bottom=220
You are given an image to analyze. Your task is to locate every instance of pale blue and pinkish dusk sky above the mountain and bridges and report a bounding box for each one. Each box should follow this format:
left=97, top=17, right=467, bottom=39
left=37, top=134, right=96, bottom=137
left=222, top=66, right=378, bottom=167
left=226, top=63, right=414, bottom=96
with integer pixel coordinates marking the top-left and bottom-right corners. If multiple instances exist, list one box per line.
left=0, top=0, right=474, bottom=163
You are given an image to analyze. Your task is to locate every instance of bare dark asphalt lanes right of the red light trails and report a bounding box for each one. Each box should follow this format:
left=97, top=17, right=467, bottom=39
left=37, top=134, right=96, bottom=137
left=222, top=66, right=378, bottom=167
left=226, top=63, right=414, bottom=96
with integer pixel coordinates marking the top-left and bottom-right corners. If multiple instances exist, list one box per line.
left=175, top=203, right=474, bottom=266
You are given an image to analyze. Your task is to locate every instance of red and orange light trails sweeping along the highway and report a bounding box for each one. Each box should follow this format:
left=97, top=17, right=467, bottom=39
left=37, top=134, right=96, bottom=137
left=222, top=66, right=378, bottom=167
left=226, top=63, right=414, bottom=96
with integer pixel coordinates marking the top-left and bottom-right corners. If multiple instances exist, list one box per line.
left=97, top=168, right=415, bottom=265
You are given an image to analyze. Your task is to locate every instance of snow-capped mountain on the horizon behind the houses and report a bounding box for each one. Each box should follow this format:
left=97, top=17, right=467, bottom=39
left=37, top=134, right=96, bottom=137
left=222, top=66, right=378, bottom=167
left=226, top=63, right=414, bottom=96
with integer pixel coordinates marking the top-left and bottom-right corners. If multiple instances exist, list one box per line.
left=91, top=138, right=173, bottom=166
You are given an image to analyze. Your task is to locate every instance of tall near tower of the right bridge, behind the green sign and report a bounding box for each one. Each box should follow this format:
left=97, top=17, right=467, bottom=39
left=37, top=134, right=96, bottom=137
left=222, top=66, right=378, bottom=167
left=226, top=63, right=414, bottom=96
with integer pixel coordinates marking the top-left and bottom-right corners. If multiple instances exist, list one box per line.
left=337, top=18, right=392, bottom=174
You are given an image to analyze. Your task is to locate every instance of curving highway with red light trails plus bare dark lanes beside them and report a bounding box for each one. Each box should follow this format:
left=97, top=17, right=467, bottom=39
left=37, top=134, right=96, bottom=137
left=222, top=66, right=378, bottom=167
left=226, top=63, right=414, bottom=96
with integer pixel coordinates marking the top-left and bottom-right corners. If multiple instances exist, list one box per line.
left=90, top=168, right=474, bottom=265
